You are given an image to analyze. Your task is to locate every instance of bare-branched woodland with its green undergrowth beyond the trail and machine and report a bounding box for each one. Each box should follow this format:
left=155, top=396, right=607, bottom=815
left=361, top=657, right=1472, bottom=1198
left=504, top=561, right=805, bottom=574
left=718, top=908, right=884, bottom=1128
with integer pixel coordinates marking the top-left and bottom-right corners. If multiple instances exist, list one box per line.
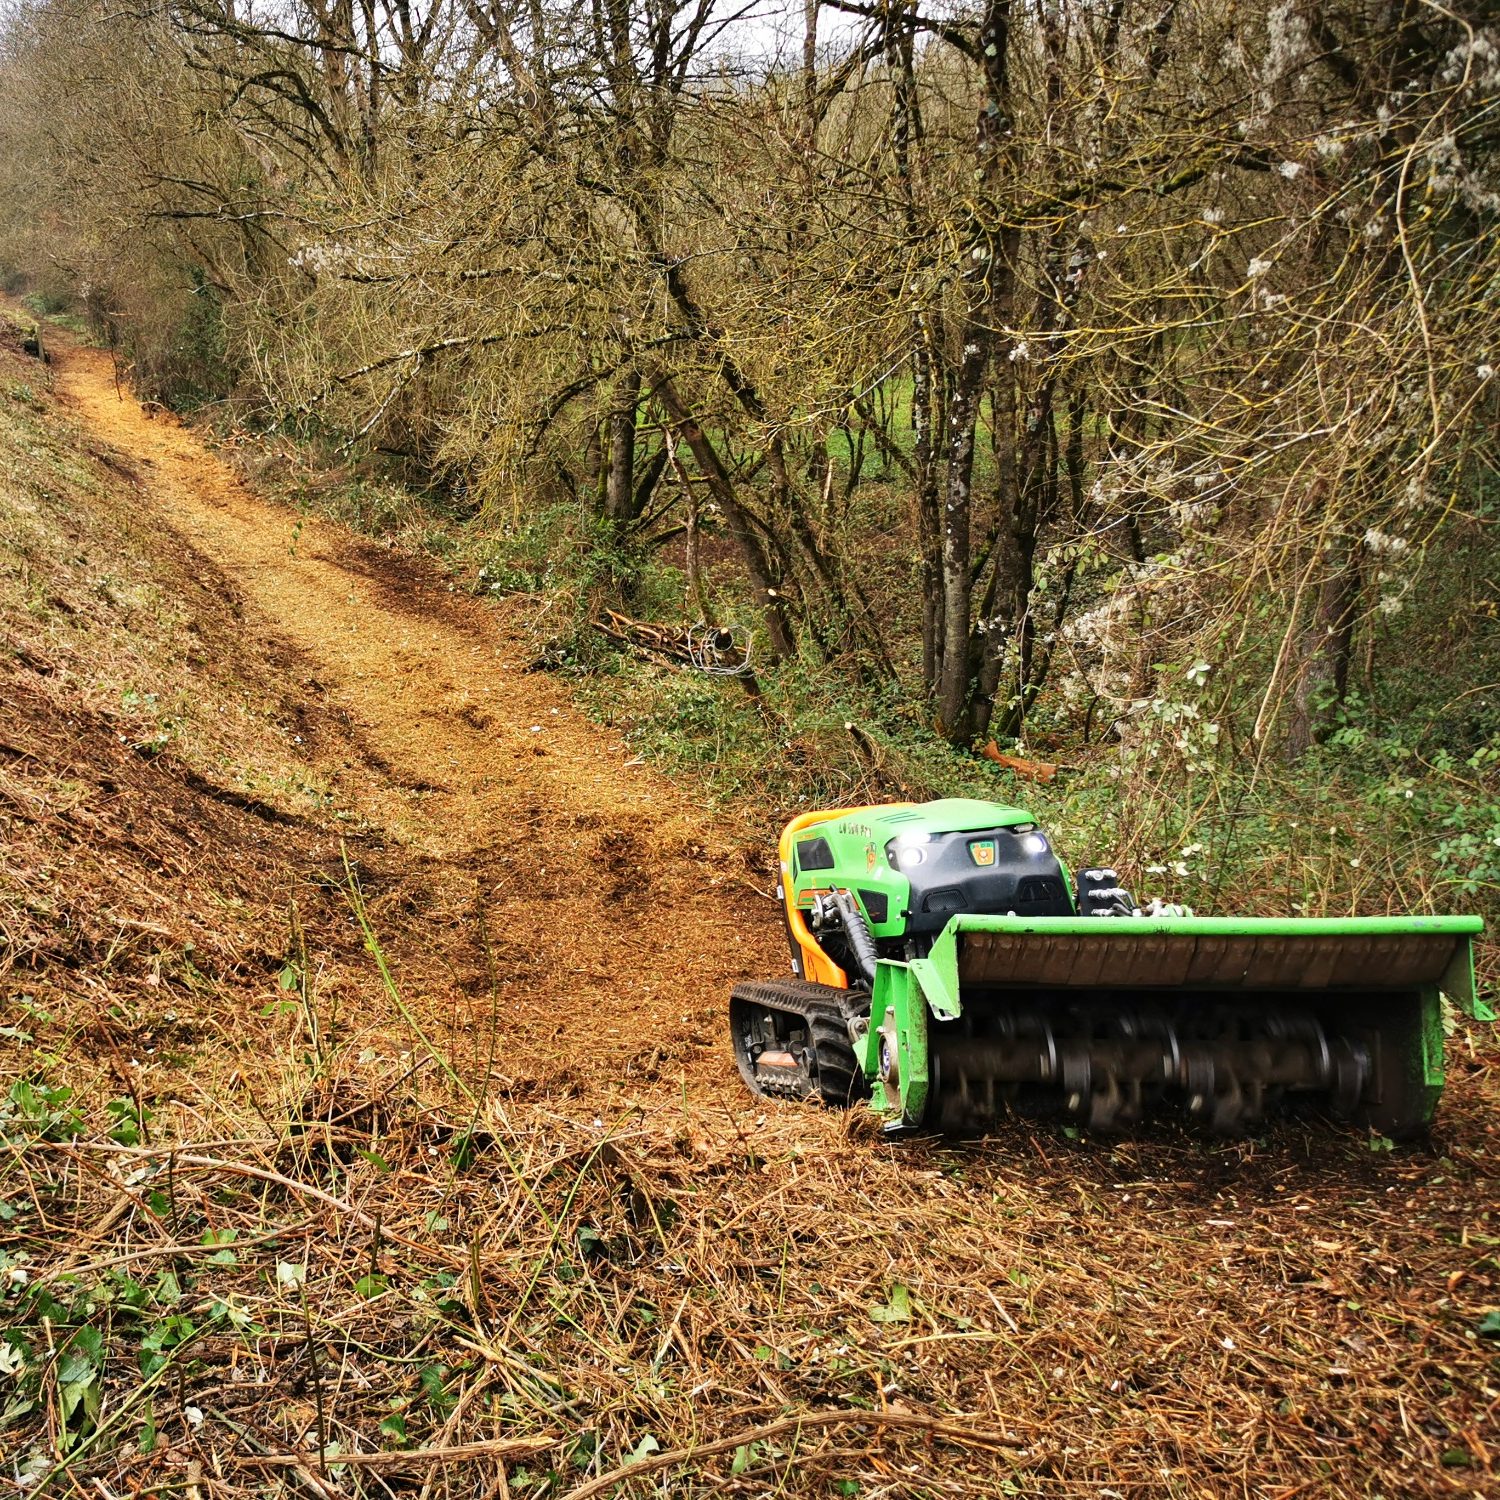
left=0, top=0, right=1500, bottom=912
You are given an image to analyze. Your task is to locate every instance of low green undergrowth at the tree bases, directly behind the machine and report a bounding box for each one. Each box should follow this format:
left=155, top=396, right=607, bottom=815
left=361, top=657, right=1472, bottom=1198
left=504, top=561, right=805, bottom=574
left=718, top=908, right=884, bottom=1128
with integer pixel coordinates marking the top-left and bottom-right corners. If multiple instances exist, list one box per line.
left=564, top=645, right=1500, bottom=960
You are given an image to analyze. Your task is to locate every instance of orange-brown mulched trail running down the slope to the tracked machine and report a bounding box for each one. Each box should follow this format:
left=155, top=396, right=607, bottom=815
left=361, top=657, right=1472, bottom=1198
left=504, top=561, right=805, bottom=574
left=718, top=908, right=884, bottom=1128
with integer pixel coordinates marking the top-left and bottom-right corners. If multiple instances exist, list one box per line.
left=56, top=342, right=779, bottom=1095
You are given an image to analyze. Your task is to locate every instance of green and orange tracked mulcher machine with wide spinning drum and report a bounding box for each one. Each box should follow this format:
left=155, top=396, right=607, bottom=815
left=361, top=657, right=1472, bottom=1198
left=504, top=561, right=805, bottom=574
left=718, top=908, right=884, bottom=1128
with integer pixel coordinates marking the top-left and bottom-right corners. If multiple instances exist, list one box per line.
left=729, top=798, right=1494, bottom=1139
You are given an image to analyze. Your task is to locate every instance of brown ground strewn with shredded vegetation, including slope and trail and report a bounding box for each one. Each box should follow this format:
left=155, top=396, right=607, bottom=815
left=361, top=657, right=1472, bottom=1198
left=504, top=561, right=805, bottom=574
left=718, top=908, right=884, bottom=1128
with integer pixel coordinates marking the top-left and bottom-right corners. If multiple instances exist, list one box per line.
left=0, top=327, right=1500, bottom=1500
